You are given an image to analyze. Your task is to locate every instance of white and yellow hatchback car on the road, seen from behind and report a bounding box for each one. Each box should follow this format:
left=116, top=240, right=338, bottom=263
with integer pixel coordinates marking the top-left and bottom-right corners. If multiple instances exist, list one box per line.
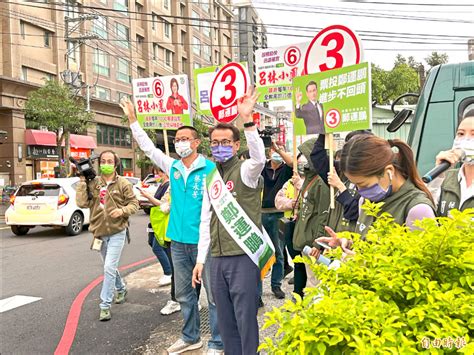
left=5, top=177, right=90, bottom=235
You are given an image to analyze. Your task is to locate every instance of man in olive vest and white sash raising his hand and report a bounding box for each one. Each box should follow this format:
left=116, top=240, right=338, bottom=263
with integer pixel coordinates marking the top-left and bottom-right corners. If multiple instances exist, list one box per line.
left=193, top=88, right=266, bottom=355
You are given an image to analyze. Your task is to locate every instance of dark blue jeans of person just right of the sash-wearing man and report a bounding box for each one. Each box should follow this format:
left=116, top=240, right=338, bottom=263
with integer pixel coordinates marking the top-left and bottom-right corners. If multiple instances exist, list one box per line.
left=262, top=212, right=285, bottom=287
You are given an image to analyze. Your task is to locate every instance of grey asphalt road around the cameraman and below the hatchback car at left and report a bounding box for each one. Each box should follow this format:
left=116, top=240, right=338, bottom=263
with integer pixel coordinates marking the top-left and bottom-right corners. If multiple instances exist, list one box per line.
left=0, top=211, right=177, bottom=354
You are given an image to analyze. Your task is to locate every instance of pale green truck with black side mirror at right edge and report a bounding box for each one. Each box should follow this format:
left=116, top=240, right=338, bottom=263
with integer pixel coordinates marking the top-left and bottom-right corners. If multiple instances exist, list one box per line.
left=388, top=61, right=474, bottom=175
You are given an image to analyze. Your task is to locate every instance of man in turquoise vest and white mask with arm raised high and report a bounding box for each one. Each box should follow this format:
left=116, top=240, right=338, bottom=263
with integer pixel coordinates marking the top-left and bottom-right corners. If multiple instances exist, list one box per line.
left=121, top=98, right=223, bottom=353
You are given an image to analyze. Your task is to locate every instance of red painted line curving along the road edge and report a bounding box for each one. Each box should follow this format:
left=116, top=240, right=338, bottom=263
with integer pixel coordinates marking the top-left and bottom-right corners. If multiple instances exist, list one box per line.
left=54, top=256, right=156, bottom=355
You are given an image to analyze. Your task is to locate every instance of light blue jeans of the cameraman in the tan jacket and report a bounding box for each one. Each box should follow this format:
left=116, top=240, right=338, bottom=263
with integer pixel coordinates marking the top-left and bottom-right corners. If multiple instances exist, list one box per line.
left=100, top=229, right=126, bottom=309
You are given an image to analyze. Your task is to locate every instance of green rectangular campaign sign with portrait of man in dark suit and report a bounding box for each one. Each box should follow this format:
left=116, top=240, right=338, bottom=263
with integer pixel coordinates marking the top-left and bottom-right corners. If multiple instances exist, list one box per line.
left=293, top=63, right=372, bottom=136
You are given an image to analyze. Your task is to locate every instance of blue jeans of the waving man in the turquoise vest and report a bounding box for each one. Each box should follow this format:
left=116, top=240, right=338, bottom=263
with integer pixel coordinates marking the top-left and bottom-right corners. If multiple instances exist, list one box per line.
left=171, top=241, right=224, bottom=350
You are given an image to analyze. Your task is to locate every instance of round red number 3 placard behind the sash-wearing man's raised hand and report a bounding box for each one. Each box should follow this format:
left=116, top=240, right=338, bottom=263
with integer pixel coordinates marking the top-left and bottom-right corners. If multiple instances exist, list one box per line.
left=211, top=62, right=250, bottom=123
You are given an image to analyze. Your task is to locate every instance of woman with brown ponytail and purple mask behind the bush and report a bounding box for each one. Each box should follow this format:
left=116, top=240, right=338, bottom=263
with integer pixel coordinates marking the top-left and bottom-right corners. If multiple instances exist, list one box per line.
left=317, top=135, right=435, bottom=252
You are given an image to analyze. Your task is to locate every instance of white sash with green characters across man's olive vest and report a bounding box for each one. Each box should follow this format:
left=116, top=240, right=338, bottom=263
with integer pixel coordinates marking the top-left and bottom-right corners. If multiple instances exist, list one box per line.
left=206, top=168, right=276, bottom=279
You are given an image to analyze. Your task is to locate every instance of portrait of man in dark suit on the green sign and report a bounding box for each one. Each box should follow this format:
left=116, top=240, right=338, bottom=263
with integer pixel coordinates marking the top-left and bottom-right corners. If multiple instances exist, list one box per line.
left=295, top=81, right=326, bottom=134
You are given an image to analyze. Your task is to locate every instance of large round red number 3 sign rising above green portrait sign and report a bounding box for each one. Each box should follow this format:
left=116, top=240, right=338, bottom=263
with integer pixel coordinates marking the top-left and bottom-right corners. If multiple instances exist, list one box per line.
left=304, top=25, right=362, bottom=74
